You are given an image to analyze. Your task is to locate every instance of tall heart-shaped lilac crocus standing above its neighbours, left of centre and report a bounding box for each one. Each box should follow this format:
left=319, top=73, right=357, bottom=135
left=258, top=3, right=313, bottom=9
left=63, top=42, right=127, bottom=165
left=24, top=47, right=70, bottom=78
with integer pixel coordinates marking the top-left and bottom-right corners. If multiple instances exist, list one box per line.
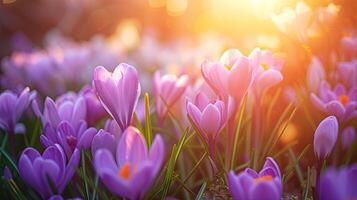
left=93, top=63, right=140, bottom=131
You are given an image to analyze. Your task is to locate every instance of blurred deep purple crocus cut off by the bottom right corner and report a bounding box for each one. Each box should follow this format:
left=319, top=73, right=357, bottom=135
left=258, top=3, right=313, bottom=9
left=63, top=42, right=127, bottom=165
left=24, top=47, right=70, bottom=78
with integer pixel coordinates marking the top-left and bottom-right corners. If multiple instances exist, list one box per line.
left=317, top=164, right=357, bottom=200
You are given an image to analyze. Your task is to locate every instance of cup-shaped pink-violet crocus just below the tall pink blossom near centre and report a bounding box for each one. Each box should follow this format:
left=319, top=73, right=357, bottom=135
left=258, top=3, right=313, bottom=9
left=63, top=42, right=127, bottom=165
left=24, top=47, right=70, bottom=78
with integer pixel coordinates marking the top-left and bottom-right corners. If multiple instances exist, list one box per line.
left=186, top=93, right=233, bottom=148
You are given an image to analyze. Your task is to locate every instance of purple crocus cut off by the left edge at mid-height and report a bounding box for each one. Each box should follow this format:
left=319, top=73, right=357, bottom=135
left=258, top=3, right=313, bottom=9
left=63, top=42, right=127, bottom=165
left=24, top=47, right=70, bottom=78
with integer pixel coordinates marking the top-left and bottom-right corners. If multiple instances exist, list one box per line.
left=0, top=88, right=36, bottom=134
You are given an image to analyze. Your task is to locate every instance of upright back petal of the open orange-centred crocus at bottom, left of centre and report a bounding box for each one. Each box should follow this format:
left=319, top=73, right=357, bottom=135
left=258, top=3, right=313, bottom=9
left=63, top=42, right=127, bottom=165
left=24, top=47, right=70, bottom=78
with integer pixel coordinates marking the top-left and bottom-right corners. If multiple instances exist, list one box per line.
left=116, top=126, right=148, bottom=166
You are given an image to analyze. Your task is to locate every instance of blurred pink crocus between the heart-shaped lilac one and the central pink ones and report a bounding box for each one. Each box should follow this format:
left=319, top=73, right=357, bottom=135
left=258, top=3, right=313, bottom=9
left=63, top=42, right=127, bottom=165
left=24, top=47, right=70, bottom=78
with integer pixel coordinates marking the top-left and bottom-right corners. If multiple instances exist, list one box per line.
left=153, top=71, right=189, bottom=122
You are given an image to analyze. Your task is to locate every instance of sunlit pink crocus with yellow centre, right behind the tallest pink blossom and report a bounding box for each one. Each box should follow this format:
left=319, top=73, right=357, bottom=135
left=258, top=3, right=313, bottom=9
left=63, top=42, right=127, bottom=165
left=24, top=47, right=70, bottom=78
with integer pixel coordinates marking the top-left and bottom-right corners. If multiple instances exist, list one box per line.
left=249, top=48, right=283, bottom=97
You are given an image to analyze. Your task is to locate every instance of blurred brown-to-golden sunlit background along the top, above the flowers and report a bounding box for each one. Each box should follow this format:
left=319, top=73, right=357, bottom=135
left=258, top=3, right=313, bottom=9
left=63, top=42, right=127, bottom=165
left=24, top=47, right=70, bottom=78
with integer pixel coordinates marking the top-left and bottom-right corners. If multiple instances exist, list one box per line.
left=0, top=0, right=357, bottom=57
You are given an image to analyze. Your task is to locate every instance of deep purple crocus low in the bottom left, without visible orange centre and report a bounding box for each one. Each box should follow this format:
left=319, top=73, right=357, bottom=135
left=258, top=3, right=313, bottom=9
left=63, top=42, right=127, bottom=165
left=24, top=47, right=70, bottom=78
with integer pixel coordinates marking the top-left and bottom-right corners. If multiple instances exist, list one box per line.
left=18, top=144, right=80, bottom=199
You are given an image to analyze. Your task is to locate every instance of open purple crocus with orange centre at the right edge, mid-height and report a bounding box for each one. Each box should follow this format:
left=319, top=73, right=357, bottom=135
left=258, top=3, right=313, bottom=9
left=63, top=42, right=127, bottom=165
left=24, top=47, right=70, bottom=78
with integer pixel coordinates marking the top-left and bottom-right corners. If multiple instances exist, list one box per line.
left=310, top=82, right=357, bottom=121
